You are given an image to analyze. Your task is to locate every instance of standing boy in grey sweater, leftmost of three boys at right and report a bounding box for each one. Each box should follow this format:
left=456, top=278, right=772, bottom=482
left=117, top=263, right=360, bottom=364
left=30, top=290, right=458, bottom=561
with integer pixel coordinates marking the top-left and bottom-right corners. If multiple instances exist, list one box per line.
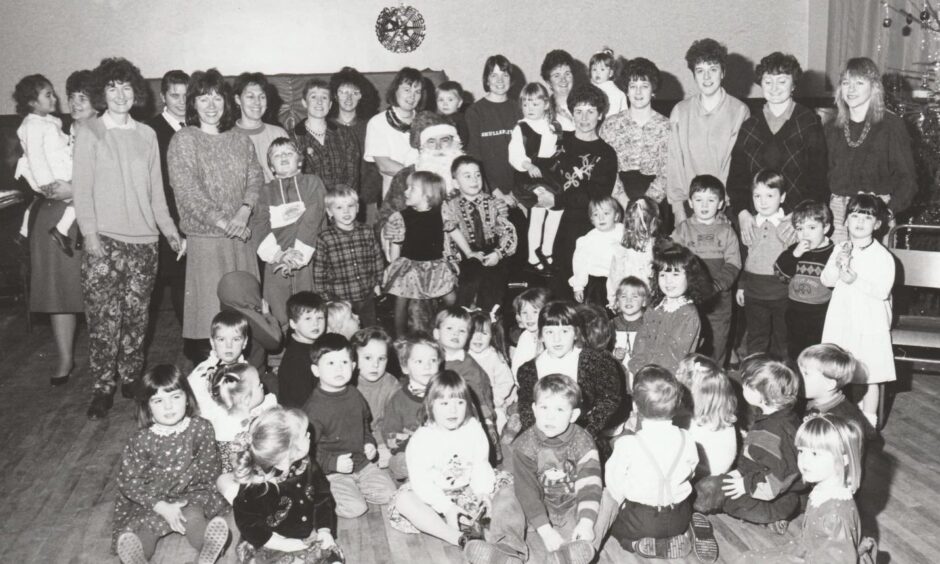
left=672, top=174, right=741, bottom=366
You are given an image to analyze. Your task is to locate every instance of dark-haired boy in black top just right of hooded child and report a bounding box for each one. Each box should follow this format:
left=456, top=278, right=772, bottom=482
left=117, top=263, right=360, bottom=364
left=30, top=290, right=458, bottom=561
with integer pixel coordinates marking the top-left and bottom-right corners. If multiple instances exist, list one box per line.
left=277, top=292, right=326, bottom=408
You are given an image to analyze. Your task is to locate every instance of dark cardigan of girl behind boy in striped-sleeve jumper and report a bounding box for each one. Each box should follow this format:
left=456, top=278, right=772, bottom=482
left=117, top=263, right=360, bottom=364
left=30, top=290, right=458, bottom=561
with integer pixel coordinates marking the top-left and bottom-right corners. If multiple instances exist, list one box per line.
left=517, top=349, right=624, bottom=439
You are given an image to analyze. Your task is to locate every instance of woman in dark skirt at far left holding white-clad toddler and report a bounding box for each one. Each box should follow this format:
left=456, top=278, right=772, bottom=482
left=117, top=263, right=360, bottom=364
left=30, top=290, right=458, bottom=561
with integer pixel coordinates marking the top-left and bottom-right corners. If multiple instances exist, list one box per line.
left=29, top=70, right=96, bottom=386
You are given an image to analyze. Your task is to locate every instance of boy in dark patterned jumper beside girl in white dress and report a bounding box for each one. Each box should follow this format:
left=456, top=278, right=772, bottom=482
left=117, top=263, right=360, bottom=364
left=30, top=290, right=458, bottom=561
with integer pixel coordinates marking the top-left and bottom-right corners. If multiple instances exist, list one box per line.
left=774, top=200, right=834, bottom=360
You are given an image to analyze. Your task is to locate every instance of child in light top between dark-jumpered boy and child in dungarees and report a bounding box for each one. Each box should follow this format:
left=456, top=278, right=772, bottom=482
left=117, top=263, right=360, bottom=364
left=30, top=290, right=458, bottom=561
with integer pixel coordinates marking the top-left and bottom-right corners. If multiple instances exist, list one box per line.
left=350, top=327, right=401, bottom=468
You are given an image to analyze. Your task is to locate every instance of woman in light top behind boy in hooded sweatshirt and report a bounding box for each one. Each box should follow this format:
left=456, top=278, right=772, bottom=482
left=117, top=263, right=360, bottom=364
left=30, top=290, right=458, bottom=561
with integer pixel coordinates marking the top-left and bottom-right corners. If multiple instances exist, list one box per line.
left=234, top=72, right=287, bottom=182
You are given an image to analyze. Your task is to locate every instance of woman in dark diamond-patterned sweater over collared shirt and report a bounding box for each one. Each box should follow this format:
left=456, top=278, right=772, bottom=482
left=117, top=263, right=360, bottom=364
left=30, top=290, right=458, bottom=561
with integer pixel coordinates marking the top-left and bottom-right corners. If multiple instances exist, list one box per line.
left=727, top=52, right=829, bottom=245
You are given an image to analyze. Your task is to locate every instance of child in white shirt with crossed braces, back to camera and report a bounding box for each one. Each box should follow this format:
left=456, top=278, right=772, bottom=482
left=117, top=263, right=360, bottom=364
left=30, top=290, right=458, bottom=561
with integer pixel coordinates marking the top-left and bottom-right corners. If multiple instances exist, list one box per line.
left=598, top=365, right=718, bottom=562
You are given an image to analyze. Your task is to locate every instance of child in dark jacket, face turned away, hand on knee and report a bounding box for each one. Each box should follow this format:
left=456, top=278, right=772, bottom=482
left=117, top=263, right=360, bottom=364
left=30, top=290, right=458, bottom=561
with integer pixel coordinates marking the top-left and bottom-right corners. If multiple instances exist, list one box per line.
left=695, top=354, right=800, bottom=534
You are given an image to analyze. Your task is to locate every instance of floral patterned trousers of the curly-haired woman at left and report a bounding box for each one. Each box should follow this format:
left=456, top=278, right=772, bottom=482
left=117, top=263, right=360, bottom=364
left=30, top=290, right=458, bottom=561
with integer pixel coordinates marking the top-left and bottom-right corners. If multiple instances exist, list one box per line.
left=82, top=236, right=157, bottom=394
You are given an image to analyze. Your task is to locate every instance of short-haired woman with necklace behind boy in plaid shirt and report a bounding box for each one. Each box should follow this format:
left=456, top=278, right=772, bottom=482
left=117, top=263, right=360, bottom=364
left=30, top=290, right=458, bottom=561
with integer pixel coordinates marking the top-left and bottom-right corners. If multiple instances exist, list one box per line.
left=294, top=78, right=362, bottom=192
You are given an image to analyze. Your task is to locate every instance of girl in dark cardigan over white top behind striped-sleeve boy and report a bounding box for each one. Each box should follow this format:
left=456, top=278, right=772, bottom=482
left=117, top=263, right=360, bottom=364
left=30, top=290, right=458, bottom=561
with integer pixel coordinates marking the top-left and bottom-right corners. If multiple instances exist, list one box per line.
left=518, top=302, right=625, bottom=452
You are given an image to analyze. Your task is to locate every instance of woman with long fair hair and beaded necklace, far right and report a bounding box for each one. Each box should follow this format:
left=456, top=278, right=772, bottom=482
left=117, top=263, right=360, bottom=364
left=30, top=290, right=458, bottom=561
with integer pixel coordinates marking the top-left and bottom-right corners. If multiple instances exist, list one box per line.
left=825, top=57, right=917, bottom=243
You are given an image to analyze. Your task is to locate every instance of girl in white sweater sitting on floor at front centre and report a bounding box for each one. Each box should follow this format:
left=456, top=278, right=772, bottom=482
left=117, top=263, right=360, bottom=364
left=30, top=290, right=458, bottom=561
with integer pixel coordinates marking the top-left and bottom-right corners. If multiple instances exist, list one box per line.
left=388, top=370, right=526, bottom=563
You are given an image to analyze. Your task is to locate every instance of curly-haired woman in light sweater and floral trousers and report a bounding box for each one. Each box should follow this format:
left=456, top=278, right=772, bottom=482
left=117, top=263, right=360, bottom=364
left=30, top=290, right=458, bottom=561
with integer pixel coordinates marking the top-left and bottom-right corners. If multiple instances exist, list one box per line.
left=72, top=59, right=186, bottom=419
